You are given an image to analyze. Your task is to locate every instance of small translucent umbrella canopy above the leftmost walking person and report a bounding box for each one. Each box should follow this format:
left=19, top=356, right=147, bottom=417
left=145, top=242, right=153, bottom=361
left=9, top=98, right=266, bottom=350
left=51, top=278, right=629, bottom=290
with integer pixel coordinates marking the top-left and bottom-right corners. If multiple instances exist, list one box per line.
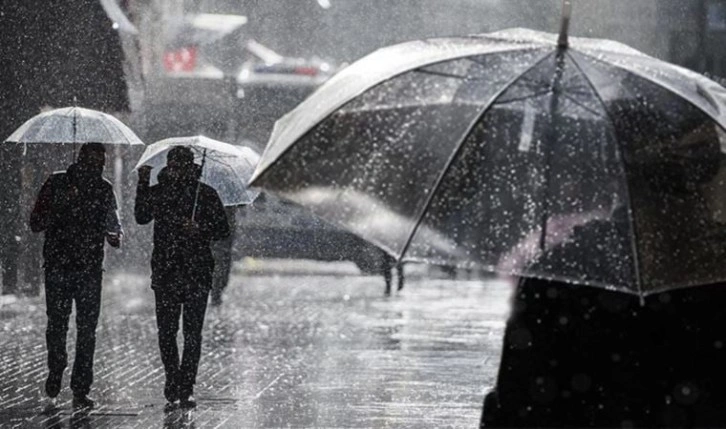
left=5, top=107, right=144, bottom=146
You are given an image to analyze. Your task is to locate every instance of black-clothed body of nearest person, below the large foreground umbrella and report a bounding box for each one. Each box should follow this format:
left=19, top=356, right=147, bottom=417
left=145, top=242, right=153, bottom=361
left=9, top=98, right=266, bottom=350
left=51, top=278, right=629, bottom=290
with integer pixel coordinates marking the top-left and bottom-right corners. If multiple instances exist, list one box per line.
left=482, top=229, right=726, bottom=428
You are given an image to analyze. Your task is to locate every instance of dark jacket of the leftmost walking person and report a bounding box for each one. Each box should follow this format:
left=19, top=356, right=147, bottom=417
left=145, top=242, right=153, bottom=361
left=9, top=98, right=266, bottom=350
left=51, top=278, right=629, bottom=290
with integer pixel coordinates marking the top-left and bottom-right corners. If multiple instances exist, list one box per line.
left=30, top=164, right=121, bottom=271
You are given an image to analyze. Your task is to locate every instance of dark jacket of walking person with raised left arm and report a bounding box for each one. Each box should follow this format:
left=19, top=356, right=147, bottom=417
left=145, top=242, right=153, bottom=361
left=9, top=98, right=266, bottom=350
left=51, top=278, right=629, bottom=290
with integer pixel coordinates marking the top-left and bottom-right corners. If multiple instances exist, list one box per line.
left=134, top=168, right=230, bottom=289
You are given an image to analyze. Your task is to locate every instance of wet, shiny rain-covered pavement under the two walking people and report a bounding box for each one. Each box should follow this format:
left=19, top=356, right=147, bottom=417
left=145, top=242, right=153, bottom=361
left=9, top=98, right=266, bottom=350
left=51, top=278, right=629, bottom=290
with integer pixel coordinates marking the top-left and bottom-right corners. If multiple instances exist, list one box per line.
left=0, top=263, right=508, bottom=428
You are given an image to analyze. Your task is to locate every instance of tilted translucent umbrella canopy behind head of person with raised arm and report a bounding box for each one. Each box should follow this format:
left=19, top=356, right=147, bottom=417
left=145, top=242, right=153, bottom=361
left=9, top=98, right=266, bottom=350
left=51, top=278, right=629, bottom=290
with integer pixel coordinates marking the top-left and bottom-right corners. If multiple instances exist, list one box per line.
left=134, top=136, right=260, bottom=206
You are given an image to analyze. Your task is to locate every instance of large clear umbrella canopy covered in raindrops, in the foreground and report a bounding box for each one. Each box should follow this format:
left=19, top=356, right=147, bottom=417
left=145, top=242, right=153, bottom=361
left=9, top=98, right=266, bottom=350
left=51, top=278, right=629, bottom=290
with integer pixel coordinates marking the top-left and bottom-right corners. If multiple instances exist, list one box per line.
left=253, top=25, right=726, bottom=295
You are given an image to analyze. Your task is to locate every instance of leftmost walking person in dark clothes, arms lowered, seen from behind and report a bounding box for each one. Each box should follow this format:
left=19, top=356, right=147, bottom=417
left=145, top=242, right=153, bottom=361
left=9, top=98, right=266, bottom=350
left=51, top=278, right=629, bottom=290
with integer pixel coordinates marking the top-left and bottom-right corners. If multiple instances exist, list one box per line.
left=30, top=143, right=123, bottom=408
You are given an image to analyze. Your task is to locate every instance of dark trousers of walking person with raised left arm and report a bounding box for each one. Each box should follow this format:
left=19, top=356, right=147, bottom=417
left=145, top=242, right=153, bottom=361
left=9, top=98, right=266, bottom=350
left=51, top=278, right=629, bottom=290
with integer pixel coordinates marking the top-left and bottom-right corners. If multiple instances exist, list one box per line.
left=154, top=276, right=211, bottom=401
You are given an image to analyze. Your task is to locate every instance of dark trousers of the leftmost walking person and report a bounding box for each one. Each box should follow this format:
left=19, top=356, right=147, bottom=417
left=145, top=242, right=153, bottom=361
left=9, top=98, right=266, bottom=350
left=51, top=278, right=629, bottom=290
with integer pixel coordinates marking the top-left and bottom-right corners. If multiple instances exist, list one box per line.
left=45, top=268, right=102, bottom=395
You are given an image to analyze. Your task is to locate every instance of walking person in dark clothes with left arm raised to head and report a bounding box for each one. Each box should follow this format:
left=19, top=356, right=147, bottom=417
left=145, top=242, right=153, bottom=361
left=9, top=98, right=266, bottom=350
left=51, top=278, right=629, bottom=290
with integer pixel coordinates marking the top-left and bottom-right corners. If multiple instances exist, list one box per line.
left=135, top=147, right=230, bottom=409
